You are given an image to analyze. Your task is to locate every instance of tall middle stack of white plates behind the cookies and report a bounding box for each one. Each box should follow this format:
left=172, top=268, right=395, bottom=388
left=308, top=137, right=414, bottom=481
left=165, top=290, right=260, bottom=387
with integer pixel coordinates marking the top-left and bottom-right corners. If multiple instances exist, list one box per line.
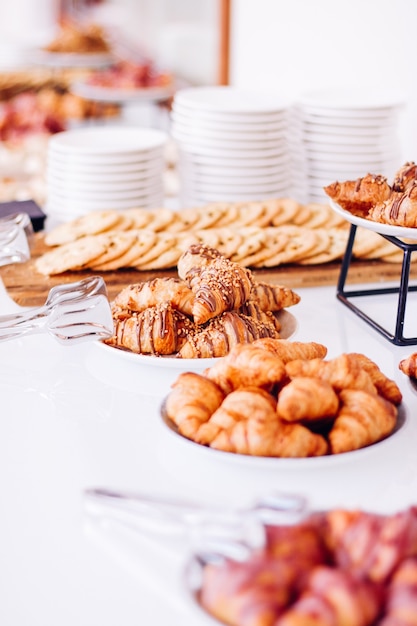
left=171, top=87, right=290, bottom=206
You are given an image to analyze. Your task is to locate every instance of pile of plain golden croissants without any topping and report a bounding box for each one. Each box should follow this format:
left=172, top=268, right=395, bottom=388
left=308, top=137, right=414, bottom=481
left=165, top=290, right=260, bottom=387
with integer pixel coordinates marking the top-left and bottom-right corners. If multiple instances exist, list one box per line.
left=164, top=338, right=402, bottom=457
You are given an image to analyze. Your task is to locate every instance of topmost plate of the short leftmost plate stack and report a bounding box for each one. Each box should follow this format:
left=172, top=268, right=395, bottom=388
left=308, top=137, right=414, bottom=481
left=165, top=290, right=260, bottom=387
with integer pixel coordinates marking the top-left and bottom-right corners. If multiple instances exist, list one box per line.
left=49, top=126, right=167, bottom=157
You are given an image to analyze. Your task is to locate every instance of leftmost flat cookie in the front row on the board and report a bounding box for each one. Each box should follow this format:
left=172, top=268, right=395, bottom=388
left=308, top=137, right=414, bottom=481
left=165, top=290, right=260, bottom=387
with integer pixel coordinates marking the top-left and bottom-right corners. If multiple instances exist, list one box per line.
left=35, top=235, right=108, bottom=276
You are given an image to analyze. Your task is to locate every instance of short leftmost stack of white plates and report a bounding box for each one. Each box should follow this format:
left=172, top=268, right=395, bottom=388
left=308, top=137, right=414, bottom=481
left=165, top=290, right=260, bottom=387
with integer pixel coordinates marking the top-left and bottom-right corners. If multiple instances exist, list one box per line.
left=46, top=126, right=167, bottom=221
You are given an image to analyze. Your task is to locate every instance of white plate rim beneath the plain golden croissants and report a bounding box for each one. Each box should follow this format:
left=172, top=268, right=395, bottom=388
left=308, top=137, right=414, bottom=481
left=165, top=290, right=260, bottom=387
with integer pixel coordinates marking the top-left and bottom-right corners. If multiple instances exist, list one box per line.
left=160, top=401, right=408, bottom=470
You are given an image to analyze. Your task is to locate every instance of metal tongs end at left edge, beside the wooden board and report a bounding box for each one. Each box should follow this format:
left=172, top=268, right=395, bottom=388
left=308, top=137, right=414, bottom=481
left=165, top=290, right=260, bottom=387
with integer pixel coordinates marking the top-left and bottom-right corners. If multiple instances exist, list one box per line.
left=0, top=213, right=33, bottom=266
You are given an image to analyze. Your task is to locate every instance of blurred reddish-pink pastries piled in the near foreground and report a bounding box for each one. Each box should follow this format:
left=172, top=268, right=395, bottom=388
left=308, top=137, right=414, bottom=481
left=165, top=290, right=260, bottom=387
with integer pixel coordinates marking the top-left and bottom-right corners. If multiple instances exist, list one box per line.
left=198, top=506, right=417, bottom=626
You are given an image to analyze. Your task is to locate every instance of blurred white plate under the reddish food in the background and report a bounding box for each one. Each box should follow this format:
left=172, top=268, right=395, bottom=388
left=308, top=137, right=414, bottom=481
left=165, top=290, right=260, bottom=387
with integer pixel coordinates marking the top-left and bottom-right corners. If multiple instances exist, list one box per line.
left=70, top=81, right=174, bottom=104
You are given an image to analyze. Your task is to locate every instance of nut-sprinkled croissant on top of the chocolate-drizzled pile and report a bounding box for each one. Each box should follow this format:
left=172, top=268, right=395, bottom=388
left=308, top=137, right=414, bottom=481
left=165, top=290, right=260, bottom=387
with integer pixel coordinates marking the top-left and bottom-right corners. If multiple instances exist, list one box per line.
left=178, top=246, right=253, bottom=324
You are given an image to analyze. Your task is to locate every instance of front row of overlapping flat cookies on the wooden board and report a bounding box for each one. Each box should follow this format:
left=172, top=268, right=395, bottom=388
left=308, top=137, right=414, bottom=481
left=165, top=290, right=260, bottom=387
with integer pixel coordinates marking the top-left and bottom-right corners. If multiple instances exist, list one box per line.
left=35, top=224, right=410, bottom=275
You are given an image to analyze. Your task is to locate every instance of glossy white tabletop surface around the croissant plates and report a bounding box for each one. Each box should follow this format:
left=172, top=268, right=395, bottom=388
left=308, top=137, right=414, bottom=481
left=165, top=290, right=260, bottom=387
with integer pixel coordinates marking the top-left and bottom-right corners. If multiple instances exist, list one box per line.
left=0, top=272, right=417, bottom=626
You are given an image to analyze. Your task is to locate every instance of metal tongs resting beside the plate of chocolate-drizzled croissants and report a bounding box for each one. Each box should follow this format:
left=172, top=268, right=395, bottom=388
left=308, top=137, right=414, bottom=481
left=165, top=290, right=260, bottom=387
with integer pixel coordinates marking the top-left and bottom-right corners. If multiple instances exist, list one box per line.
left=0, top=276, right=113, bottom=345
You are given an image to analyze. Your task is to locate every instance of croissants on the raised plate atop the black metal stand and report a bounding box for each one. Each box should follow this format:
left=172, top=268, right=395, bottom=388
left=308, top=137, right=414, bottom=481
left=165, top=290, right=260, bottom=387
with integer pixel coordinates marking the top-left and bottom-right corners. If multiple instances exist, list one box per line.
left=324, top=161, right=417, bottom=228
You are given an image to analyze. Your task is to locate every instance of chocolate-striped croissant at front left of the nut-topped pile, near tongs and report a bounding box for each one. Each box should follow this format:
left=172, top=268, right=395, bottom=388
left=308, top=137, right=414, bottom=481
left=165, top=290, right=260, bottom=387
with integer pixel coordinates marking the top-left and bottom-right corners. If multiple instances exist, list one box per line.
left=104, top=302, right=194, bottom=355
